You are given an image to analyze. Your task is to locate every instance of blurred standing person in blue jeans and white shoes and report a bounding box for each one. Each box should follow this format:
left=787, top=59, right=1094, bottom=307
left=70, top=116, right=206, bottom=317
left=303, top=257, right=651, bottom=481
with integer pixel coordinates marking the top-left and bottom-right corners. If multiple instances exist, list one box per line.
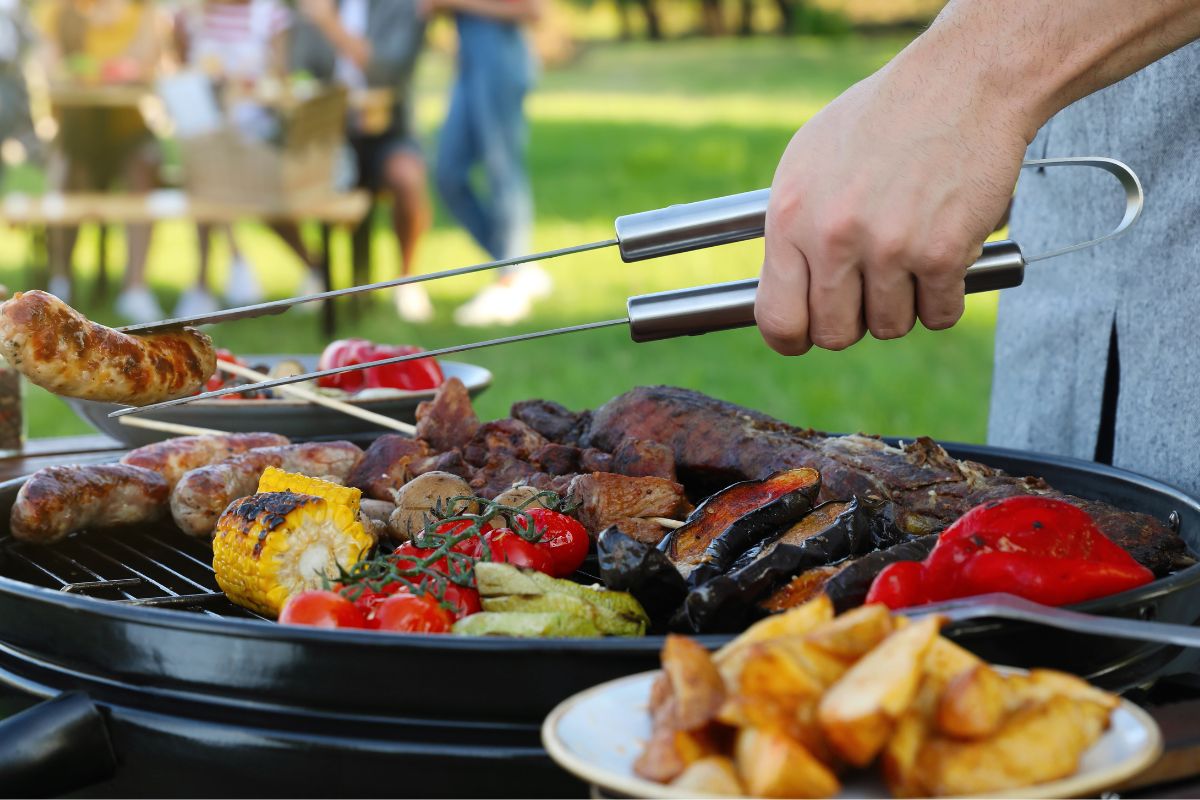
left=424, top=0, right=551, bottom=325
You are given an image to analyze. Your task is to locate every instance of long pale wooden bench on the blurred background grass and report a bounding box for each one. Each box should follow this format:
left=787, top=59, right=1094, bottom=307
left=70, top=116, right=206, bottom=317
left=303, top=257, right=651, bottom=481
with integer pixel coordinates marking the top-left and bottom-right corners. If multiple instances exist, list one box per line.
left=0, top=191, right=371, bottom=338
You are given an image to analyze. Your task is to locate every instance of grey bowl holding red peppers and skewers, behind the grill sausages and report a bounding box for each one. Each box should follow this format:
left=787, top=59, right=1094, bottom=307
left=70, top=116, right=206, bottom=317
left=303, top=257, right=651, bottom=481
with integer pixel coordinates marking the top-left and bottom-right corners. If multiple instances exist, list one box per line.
left=62, top=355, right=492, bottom=447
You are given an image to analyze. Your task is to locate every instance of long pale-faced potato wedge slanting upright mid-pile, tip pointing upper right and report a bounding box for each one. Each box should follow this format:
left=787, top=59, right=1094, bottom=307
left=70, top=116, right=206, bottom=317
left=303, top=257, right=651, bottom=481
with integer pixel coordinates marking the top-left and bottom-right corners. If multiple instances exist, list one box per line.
left=817, top=616, right=943, bottom=766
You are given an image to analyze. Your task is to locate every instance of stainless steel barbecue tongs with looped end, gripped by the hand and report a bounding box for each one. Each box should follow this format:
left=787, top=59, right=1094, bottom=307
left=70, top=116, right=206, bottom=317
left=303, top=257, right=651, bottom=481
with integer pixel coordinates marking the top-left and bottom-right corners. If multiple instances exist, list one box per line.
left=109, top=156, right=1144, bottom=416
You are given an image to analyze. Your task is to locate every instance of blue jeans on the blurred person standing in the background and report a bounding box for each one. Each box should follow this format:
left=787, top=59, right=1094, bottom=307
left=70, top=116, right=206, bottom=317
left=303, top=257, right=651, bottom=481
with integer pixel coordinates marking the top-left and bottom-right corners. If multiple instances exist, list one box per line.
left=434, top=14, right=533, bottom=259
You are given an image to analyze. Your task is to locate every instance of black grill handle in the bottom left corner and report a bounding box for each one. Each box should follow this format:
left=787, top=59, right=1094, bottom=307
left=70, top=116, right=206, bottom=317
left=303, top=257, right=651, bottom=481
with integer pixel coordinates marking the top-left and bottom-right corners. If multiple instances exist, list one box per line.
left=0, top=692, right=116, bottom=798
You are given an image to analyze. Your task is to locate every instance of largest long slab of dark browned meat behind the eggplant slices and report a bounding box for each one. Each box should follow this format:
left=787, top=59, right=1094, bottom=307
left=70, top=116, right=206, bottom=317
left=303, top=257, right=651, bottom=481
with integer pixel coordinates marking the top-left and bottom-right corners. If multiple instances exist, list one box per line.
left=584, top=386, right=1190, bottom=575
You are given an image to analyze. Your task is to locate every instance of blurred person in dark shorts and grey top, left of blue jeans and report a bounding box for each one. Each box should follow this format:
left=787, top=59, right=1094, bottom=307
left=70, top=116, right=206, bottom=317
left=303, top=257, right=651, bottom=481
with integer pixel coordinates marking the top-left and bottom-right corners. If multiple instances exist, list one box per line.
left=292, top=0, right=433, bottom=323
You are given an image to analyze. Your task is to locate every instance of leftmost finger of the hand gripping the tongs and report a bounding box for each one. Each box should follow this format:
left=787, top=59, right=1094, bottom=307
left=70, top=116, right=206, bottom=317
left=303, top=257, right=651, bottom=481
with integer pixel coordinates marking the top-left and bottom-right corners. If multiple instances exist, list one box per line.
left=754, top=233, right=812, bottom=355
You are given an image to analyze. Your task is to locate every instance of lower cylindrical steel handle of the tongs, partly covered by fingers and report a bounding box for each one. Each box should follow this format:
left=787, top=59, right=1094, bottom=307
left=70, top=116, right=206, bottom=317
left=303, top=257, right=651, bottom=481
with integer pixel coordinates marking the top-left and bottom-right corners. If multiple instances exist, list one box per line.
left=626, top=240, right=1025, bottom=342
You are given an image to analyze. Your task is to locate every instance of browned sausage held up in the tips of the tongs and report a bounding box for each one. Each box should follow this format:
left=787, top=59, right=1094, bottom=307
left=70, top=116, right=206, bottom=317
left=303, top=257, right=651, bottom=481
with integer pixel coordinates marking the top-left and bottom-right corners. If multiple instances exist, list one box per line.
left=0, top=291, right=217, bottom=405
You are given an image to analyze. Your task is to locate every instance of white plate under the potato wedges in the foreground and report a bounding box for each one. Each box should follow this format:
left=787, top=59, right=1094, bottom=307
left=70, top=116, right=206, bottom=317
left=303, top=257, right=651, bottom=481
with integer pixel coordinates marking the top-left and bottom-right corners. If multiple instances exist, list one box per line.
left=541, top=672, right=1163, bottom=798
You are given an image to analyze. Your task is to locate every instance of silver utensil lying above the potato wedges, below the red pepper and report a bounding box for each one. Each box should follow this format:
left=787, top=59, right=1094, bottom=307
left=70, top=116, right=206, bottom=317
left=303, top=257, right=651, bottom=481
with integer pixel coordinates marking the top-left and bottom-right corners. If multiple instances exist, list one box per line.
left=901, top=594, right=1200, bottom=648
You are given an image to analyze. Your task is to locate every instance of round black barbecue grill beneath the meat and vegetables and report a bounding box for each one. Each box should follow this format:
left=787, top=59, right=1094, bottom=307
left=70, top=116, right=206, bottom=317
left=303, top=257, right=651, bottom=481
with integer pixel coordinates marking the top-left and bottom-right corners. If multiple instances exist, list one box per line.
left=0, top=445, right=1200, bottom=796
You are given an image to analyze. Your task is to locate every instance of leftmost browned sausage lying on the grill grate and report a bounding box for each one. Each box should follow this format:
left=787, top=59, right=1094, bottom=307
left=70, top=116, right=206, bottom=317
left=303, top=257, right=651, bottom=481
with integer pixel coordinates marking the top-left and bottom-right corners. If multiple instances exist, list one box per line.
left=10, top=464, right=169, bottom=545
